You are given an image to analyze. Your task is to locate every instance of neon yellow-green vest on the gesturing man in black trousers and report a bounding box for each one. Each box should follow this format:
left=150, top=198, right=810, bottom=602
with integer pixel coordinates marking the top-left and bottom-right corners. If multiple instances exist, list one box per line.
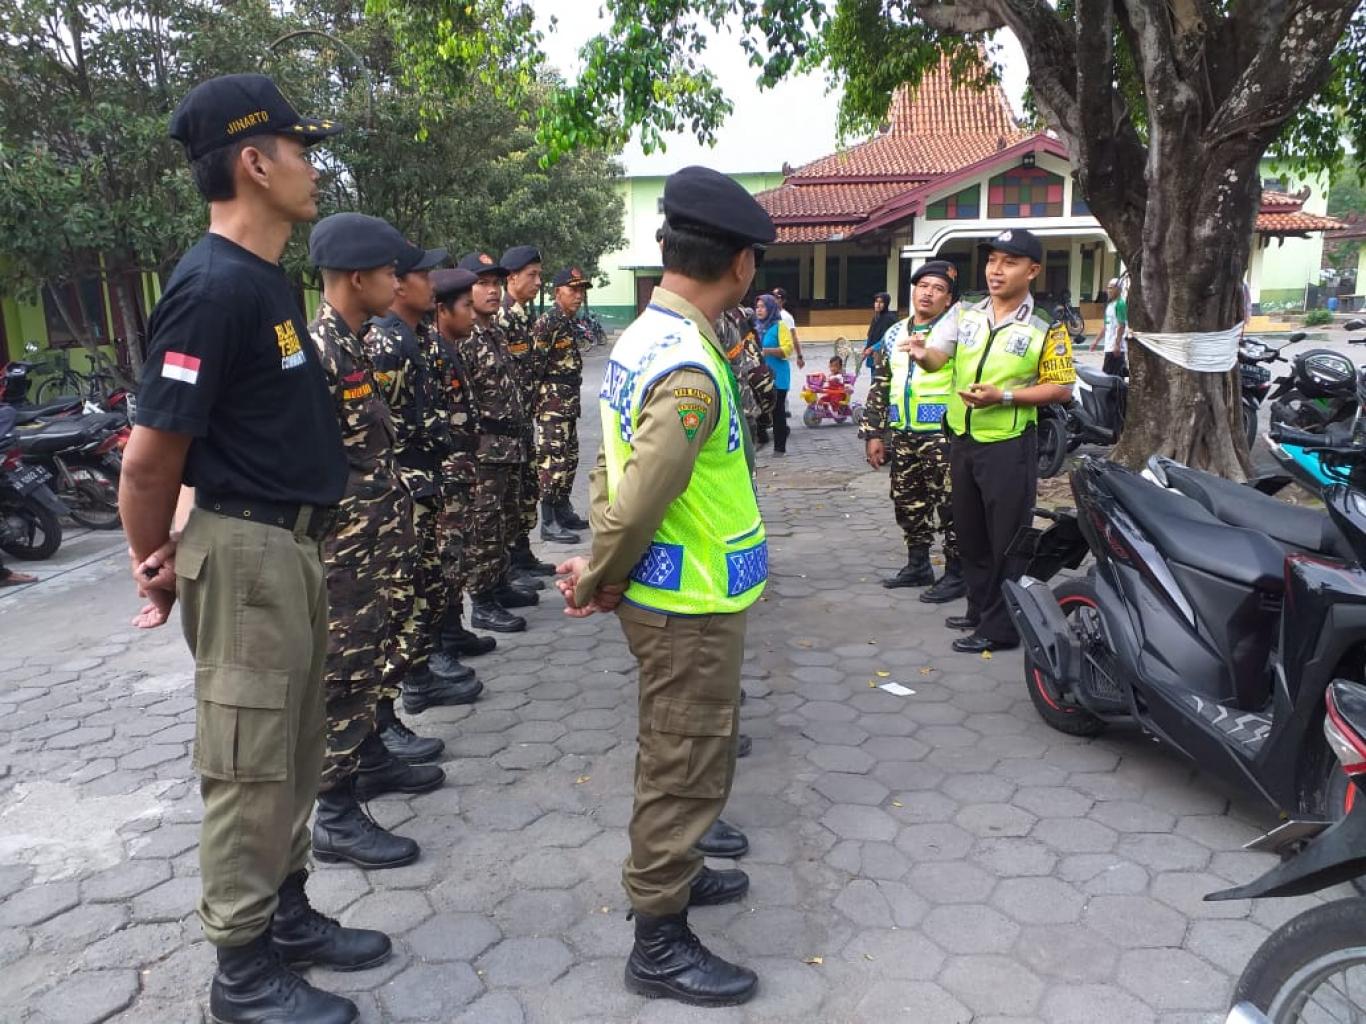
left=948, top=299, right=1053, bottom=441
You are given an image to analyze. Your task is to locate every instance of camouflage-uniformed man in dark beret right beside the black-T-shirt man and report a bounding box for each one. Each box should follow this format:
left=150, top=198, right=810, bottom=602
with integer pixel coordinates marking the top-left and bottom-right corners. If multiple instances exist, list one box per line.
left=309, top=213, right=445, bottom=868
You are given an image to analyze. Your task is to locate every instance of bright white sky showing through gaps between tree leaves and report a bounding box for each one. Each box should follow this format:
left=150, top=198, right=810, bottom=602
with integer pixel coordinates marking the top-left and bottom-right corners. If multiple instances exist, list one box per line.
left=531, top=0, right=1026, bottom=175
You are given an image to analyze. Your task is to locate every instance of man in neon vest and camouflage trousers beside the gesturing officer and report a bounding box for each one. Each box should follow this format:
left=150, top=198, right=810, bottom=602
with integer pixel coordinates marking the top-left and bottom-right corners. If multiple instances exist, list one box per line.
left=859, top=259, right=967, bottom=603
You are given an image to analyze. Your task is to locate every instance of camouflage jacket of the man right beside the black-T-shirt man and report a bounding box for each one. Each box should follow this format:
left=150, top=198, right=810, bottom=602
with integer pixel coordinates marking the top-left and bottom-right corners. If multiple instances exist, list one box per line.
left=309, top=299, right=411, bottom=550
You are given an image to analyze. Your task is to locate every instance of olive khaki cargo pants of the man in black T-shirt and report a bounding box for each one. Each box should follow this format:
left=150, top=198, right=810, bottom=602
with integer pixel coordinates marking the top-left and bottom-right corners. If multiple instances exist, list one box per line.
left=175, top=508, right=328, bottom=946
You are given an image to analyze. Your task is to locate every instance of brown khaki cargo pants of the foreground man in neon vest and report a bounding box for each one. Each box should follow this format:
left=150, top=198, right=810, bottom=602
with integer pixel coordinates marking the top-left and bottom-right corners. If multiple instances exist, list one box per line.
left=616, top=603, right=744, bottom=916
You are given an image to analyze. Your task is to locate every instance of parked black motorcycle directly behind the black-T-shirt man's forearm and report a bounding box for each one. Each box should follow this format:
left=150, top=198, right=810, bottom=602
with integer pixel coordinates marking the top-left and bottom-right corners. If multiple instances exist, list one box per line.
left=14, top=412, right=128, bottom=530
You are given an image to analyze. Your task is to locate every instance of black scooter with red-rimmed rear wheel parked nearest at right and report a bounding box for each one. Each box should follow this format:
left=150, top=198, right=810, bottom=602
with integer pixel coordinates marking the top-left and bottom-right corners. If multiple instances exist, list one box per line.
left=1005, top=427, right=1366, bottom=819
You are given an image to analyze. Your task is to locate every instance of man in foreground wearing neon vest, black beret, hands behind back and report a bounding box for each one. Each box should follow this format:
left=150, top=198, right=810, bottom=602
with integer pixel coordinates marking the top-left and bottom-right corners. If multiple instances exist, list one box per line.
left=557, top=167, right=776, bottom=1006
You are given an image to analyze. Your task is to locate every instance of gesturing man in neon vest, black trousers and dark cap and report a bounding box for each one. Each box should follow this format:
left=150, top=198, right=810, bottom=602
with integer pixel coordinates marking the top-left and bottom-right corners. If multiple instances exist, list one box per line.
left=900, top=228, right=1076, bottom=654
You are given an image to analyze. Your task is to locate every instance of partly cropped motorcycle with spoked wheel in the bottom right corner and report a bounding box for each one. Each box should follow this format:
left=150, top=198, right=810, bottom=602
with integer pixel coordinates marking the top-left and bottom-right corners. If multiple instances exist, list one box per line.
left=1205, top=679, right=1366, bottom=1024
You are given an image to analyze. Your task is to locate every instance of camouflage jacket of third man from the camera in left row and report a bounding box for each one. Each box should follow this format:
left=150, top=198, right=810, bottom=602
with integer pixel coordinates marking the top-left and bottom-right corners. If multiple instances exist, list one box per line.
left=363, top=313, right=451, bottom=497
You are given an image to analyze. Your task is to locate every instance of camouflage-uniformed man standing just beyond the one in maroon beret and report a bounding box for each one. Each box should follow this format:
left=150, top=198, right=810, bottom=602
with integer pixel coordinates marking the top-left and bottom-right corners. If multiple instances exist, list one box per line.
left=456, top=253, right=540, bottom=634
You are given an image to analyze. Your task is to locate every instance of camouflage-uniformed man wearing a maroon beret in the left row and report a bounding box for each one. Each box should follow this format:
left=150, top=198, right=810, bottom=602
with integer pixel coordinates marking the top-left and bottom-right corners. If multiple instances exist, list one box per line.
left=426, top=270, right=497, bottom=657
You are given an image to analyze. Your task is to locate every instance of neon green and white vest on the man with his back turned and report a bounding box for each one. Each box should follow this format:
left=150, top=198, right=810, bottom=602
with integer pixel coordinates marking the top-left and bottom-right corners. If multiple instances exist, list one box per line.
left=598, top=303, right=768, bottom=616
